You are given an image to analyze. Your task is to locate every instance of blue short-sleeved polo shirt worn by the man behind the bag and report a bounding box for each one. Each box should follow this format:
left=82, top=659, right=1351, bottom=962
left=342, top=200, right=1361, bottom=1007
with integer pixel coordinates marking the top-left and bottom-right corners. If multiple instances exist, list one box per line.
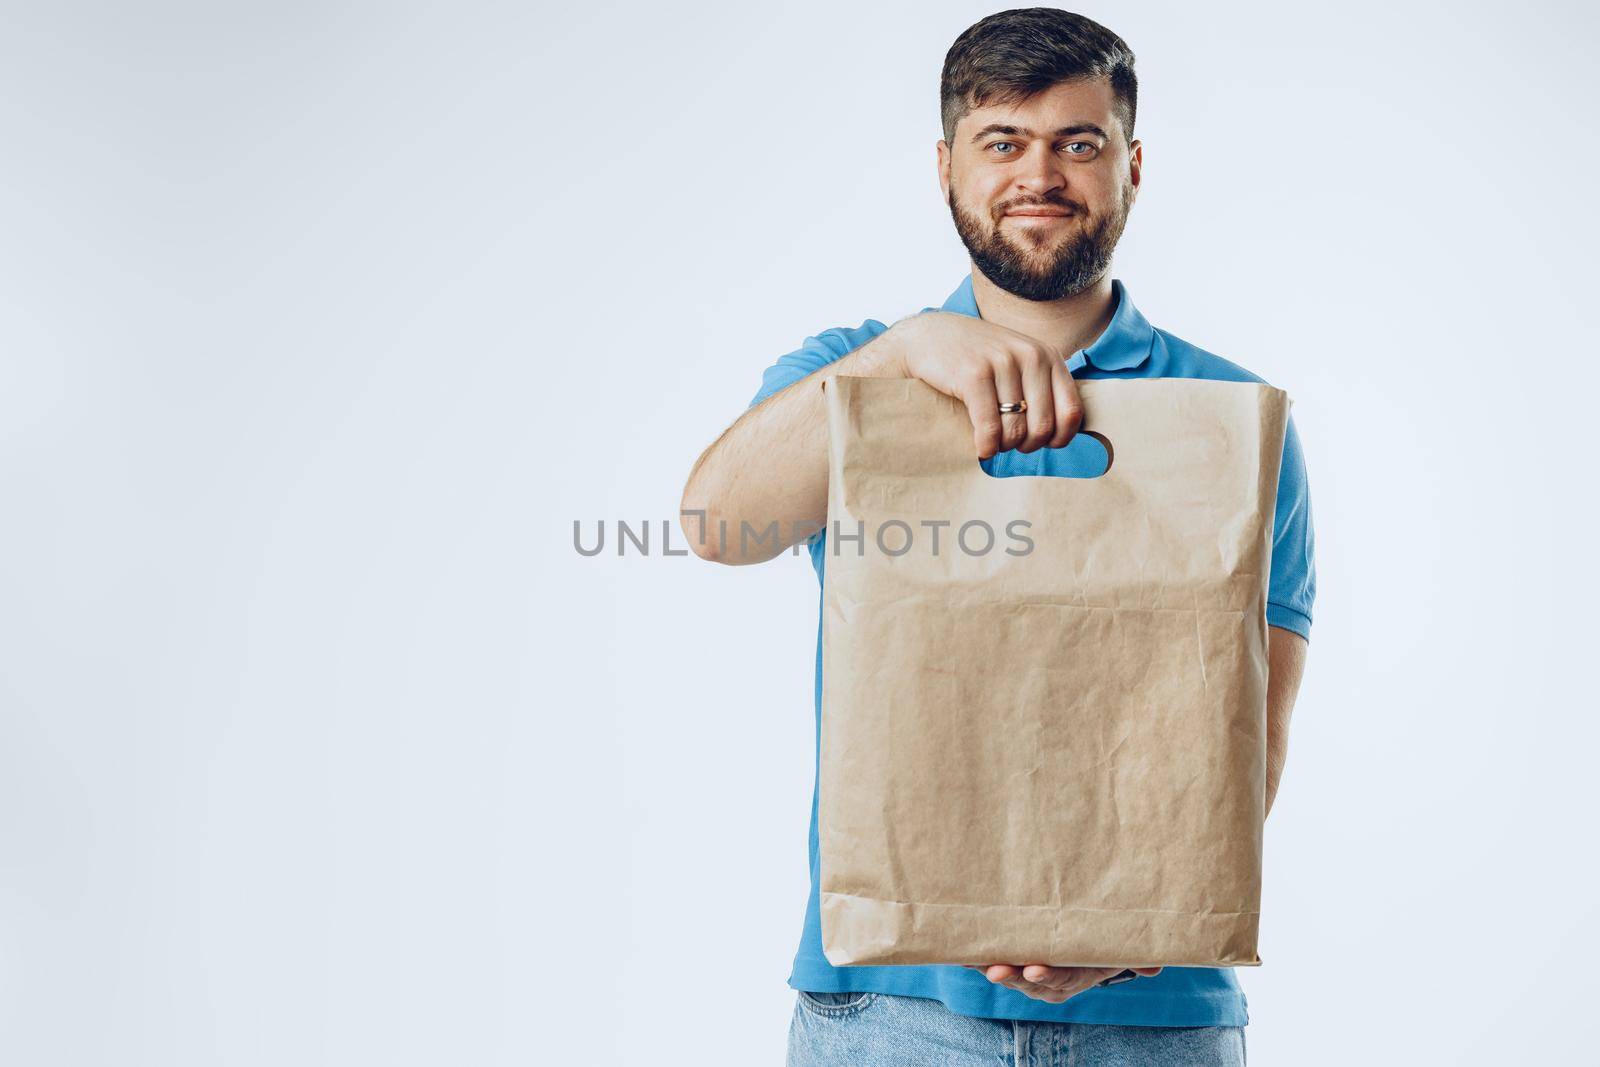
left=750, top=275, right=1317, bottom=1027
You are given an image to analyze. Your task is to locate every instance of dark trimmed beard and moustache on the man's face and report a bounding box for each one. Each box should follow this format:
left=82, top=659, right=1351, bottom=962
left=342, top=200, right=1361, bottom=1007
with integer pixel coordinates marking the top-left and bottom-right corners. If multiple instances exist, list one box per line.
left=950, top=184, right=1133, bottom=301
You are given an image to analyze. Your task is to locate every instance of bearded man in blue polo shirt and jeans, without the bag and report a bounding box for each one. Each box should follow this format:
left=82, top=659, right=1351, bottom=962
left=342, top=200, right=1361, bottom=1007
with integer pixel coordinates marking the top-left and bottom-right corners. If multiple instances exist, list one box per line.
left=683, top=8, right=1315, bottom=1064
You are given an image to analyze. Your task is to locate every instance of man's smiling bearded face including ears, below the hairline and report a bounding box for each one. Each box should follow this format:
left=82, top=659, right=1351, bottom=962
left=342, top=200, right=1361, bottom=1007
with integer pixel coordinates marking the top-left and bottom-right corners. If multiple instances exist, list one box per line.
left=939, top=78, right=1142, bottom=301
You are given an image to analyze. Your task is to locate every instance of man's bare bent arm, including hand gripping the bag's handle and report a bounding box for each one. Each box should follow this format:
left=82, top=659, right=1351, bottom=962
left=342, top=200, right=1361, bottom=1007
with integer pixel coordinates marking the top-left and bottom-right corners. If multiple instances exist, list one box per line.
left=680, top=312, right=1083, bottom=563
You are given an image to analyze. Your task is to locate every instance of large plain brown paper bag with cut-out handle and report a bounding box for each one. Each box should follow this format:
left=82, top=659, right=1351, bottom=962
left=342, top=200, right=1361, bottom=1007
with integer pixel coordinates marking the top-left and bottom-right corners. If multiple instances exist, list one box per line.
left=818, top=376, right=1291, bottom=966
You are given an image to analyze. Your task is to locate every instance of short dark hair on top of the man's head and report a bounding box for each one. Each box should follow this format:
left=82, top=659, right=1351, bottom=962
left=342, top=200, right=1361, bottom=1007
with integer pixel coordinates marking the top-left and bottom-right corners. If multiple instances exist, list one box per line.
left=939, top=8, right=1139, bottom=147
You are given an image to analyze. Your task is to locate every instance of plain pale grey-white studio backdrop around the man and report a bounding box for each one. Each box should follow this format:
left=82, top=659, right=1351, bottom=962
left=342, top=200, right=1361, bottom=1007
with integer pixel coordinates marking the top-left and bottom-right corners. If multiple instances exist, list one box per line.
left=0, top=3, right=1600, bottom=1067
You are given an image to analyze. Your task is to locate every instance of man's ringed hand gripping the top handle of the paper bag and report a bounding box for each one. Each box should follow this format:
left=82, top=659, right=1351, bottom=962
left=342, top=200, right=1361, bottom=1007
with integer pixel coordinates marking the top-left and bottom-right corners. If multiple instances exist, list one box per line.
left=875, top=312, right=1083, bottom=459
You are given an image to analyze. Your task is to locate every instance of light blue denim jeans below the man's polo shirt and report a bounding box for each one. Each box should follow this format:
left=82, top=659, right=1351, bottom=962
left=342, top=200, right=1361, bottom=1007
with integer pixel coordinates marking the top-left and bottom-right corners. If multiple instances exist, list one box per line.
left=786, top=993, right=1245, bottom=1067
